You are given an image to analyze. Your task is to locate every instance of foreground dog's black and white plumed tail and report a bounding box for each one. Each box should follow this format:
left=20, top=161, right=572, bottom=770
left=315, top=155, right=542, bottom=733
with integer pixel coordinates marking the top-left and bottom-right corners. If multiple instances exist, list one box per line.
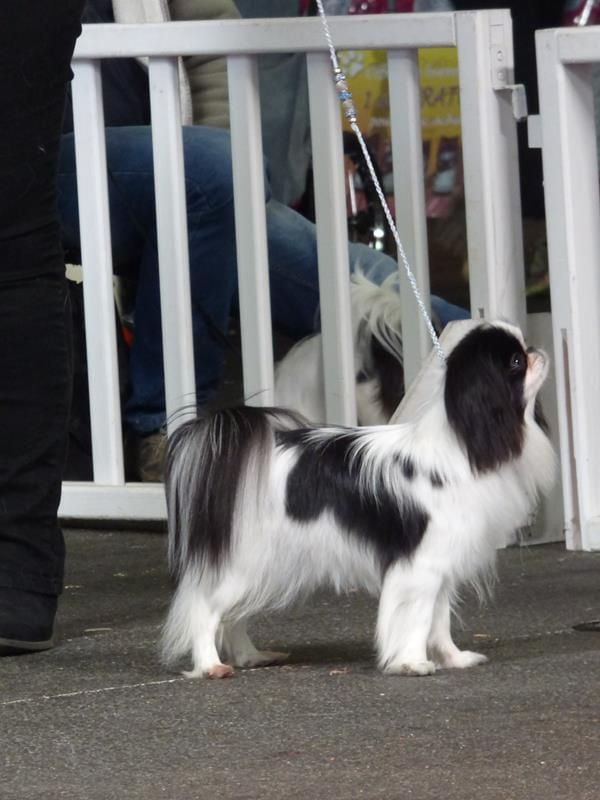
left=165, top=406, right=306, bottom=582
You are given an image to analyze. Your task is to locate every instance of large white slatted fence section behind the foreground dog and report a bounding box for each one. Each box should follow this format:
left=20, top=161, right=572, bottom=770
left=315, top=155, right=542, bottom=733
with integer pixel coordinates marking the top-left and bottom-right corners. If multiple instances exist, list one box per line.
left=59, top=11, right=525, bottom=520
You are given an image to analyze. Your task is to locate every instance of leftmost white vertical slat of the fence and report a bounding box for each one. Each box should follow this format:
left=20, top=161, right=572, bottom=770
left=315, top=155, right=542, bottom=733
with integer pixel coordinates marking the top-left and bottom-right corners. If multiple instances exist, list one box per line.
left=72, top=60, right=125, bottom=485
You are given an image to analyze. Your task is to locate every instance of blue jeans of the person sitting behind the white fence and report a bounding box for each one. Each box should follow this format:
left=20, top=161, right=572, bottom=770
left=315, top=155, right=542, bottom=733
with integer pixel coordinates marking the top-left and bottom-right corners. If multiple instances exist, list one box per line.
left=58, top=126, right=466, bottom=434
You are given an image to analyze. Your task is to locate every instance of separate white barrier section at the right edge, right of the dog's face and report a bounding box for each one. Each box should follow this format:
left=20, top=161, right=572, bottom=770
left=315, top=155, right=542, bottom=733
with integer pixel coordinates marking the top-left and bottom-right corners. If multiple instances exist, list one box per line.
left=536, top=27, right=600, bottom=550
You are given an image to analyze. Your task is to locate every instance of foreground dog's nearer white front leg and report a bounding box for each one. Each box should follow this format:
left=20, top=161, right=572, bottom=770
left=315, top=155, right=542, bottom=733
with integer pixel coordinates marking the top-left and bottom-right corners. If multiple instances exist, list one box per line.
left=377, top=560, right=441, bottom=675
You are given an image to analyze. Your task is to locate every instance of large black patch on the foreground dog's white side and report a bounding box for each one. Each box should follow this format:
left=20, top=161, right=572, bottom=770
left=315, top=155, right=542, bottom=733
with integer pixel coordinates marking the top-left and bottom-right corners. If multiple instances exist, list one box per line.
left=278, top=431, right=429, bottom=571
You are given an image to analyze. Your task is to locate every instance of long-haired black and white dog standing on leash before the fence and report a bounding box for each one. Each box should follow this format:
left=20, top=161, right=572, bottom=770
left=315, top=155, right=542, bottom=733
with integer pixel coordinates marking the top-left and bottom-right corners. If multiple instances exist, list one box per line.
left=163, top=323, right=555, bottom=677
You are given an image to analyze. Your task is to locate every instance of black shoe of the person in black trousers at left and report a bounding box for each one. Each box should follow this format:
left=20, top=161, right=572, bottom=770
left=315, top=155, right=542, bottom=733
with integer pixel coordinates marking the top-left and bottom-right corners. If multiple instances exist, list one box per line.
left=0, top=587, right=57, bottom=656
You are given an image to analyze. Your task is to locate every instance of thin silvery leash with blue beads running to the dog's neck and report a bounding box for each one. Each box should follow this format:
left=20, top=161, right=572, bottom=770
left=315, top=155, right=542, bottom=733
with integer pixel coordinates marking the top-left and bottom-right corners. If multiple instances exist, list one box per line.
left=317, top=0, right=446, bottom=361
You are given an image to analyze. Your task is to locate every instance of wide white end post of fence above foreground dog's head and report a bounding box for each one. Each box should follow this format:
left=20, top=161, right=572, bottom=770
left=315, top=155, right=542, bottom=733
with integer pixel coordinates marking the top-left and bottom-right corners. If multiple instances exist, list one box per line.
left=456, top=11, right=526, bottom=329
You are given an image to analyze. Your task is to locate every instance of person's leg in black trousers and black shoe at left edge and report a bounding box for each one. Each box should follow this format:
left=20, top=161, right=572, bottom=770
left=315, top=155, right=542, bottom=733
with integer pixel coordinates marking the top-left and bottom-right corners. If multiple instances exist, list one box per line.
left=0, top=0, right=83, bottom=655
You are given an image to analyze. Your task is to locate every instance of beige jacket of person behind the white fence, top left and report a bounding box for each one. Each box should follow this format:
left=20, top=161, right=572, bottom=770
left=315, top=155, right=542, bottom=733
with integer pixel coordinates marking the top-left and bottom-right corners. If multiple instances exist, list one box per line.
left=113, top=0, right=240, bottom=128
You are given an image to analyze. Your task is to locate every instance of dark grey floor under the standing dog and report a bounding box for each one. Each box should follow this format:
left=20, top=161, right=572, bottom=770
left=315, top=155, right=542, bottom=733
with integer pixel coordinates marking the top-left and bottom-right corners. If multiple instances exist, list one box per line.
left=0, top=530, right=600, bottom=800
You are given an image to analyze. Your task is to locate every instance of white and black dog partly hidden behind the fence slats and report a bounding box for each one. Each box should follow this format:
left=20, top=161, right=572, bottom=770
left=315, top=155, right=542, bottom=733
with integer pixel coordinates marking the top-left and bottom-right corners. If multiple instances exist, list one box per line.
left=275, top=269, right=404, bottom=425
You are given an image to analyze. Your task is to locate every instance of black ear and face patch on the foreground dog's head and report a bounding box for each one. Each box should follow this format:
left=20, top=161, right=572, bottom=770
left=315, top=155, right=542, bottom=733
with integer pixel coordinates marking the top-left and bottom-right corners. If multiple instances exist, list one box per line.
left=444, top=327, right=527, bottom=473
